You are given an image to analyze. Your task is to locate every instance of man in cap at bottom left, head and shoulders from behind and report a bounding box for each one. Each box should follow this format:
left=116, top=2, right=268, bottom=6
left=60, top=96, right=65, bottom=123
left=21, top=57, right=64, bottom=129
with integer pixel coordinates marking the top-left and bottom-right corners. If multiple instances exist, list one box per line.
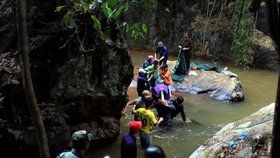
left=56, top=130, right=93, bottom=158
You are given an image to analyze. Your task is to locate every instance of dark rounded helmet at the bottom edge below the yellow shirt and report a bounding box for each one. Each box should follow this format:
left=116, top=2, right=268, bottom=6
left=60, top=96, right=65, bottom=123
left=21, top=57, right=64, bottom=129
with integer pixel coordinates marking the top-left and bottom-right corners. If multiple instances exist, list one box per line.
left=145, top=144, right=166, bottom=158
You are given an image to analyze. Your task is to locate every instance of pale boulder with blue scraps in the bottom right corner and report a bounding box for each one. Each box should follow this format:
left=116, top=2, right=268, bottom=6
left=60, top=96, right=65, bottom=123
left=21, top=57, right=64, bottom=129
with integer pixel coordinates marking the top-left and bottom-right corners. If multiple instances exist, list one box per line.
left=190, top=103, right=275, bottom=158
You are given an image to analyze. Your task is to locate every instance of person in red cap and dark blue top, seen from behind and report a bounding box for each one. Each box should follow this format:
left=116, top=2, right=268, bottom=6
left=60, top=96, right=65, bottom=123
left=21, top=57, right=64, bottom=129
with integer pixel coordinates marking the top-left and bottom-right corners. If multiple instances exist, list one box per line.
left=121, top=121, right=142, bottom=158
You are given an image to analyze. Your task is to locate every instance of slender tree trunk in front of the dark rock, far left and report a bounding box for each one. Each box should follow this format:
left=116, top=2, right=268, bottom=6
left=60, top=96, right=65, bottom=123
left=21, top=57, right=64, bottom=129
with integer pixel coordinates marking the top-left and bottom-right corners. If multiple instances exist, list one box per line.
left=17, top=0, right=50, bottom=158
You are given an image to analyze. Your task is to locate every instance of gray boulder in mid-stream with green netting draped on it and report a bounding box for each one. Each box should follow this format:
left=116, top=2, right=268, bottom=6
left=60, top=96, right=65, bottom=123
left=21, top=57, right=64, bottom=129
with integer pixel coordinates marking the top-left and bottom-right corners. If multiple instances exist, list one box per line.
left=173, top=71, right=244, bottom=102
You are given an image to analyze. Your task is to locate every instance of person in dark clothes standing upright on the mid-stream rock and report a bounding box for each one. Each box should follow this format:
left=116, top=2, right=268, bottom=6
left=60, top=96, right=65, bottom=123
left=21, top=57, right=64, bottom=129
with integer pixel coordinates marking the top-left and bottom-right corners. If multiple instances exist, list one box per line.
left=179, top=32, right=191, bottom=74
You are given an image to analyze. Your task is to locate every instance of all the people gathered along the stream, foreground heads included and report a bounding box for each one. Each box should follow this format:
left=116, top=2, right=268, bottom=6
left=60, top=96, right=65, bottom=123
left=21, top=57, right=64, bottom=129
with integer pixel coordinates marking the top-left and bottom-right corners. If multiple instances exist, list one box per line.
left=57, top=32, right=191, bottom=158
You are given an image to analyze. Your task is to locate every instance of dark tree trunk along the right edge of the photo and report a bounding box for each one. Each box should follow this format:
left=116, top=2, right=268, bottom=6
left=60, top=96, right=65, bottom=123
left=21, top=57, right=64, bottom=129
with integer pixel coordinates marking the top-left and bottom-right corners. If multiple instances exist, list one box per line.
left=266, top=0, right=280, bottom=158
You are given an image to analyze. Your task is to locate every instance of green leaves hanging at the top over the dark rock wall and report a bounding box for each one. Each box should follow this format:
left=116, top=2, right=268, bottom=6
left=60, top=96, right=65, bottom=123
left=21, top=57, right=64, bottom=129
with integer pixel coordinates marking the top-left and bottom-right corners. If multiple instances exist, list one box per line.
left=55, top=0, right=148, bottom=40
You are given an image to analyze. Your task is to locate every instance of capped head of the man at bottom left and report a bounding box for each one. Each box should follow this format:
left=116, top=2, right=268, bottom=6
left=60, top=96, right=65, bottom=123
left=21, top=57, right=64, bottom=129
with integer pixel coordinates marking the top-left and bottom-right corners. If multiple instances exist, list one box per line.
left=72, top=130, right=93, bottom=150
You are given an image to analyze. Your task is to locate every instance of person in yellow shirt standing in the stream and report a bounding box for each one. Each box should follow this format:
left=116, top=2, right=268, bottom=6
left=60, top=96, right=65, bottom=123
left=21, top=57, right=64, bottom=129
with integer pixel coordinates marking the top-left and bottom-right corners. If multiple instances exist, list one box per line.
left=132, top=97, right=163, bottom=149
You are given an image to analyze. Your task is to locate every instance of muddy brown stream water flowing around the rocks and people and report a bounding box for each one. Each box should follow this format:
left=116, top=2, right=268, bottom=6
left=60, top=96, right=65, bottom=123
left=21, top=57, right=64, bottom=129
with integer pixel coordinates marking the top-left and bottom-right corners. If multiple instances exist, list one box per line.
left=87, top=51, right=277, bottom=158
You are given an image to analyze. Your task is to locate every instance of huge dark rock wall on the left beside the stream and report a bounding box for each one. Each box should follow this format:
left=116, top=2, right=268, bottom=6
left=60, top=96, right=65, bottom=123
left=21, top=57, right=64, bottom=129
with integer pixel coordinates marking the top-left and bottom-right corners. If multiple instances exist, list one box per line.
left=0, top=1, right=133, bottom=157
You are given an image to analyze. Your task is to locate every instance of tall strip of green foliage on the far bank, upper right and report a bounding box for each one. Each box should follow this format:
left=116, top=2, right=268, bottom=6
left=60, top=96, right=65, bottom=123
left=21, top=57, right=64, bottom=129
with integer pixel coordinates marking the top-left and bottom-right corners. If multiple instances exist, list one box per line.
left=233, top=0, right=253, bottom=66
